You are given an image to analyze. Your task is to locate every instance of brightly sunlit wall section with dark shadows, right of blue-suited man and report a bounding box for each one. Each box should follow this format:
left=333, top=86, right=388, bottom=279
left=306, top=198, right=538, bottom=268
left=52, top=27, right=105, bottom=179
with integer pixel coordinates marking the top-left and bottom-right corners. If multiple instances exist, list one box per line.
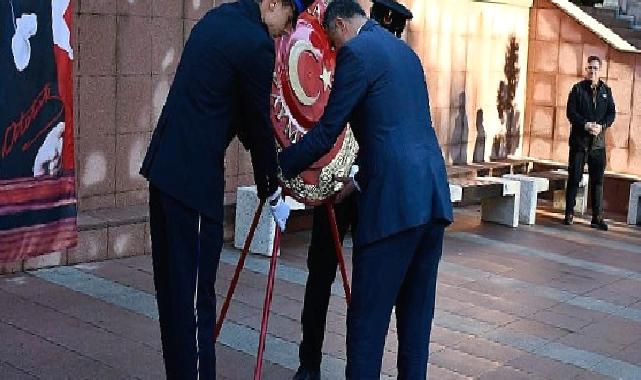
left=405, top=0, right=529, bottom=163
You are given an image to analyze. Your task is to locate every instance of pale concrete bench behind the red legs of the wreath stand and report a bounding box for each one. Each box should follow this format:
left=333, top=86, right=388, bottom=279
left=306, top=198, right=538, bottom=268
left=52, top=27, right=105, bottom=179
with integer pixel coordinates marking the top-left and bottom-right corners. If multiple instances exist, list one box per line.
left=234, top=186, right=305, bottom=256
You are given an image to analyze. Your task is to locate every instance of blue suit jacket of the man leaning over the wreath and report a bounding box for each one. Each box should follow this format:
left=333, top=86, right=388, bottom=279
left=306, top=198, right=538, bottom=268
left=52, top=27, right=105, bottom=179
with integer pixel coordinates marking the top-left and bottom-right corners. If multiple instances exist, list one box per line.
left=279, top=20, right=453, bottom=246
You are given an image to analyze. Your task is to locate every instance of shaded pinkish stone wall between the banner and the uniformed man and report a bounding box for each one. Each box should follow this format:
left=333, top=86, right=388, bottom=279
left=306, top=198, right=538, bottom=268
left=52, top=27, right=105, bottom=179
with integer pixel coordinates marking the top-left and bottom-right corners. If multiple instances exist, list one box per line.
left=75, top=0, right=246, bottom=211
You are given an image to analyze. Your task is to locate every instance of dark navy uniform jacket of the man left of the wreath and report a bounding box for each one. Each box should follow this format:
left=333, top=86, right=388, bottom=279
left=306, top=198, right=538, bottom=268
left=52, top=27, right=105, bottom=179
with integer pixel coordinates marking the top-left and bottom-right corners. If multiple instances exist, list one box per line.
left=140, top=0, right=277, bottom=222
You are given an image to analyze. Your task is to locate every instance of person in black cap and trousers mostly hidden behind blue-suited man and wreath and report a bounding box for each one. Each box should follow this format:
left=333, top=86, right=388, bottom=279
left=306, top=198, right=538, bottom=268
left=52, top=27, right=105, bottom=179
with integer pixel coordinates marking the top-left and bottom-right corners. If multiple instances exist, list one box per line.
left=293, top=0, right=412, bottom=380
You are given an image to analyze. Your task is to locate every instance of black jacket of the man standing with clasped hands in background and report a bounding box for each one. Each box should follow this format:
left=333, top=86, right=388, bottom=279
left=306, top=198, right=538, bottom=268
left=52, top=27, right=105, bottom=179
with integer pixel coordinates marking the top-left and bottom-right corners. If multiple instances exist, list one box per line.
left=566, top=80, right=616, bottom=149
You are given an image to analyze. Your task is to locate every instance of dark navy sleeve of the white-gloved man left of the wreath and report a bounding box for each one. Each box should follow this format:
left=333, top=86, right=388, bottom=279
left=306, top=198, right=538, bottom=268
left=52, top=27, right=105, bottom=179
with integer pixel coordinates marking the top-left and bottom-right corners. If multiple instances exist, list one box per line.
left=238, top=43, right=278, bottom=199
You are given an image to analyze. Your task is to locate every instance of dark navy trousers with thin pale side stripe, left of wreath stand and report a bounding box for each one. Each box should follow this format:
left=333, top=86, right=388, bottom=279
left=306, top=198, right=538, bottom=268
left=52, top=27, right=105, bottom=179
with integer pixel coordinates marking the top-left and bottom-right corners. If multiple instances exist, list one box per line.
left=149, top=185, right=223, bottom=380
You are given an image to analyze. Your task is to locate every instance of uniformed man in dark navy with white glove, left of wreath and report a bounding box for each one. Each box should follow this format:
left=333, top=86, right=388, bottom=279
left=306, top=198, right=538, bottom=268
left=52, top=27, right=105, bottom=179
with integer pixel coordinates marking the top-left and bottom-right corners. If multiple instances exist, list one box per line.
left=141, top=0, right=310, bottom=379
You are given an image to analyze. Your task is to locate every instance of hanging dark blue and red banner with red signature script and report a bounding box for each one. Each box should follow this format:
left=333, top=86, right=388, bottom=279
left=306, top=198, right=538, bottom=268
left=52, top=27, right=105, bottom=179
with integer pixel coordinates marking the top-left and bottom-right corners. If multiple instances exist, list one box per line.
left=0, top=0, right=77, bottom=262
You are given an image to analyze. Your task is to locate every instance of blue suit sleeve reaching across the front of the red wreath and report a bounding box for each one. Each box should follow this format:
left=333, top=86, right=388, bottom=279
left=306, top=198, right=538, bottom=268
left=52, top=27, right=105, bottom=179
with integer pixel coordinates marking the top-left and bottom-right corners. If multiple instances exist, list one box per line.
left=278, top=46, right=367, bottom=178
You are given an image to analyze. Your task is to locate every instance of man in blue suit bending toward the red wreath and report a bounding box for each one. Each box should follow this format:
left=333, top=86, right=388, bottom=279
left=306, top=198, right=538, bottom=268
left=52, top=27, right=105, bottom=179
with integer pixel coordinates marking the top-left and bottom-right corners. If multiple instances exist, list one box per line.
left=279, top=0, right=453, bottom=379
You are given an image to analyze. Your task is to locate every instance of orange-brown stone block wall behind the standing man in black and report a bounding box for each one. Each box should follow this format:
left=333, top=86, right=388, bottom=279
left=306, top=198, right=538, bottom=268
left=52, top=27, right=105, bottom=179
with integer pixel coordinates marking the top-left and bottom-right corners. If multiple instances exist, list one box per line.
left=524, top=0, right=641, bottom=176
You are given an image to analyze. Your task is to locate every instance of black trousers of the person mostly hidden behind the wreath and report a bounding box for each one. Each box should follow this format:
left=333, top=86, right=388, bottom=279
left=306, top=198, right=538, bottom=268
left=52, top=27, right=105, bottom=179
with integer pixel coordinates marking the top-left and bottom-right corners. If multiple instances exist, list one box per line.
left=298, top=193, right=358, bottom=369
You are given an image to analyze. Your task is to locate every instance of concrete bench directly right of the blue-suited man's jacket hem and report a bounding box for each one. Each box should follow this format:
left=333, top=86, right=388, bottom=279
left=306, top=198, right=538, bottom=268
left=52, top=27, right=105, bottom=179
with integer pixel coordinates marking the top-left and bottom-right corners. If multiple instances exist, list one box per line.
left=450, top=177, right=521, bottom=227
